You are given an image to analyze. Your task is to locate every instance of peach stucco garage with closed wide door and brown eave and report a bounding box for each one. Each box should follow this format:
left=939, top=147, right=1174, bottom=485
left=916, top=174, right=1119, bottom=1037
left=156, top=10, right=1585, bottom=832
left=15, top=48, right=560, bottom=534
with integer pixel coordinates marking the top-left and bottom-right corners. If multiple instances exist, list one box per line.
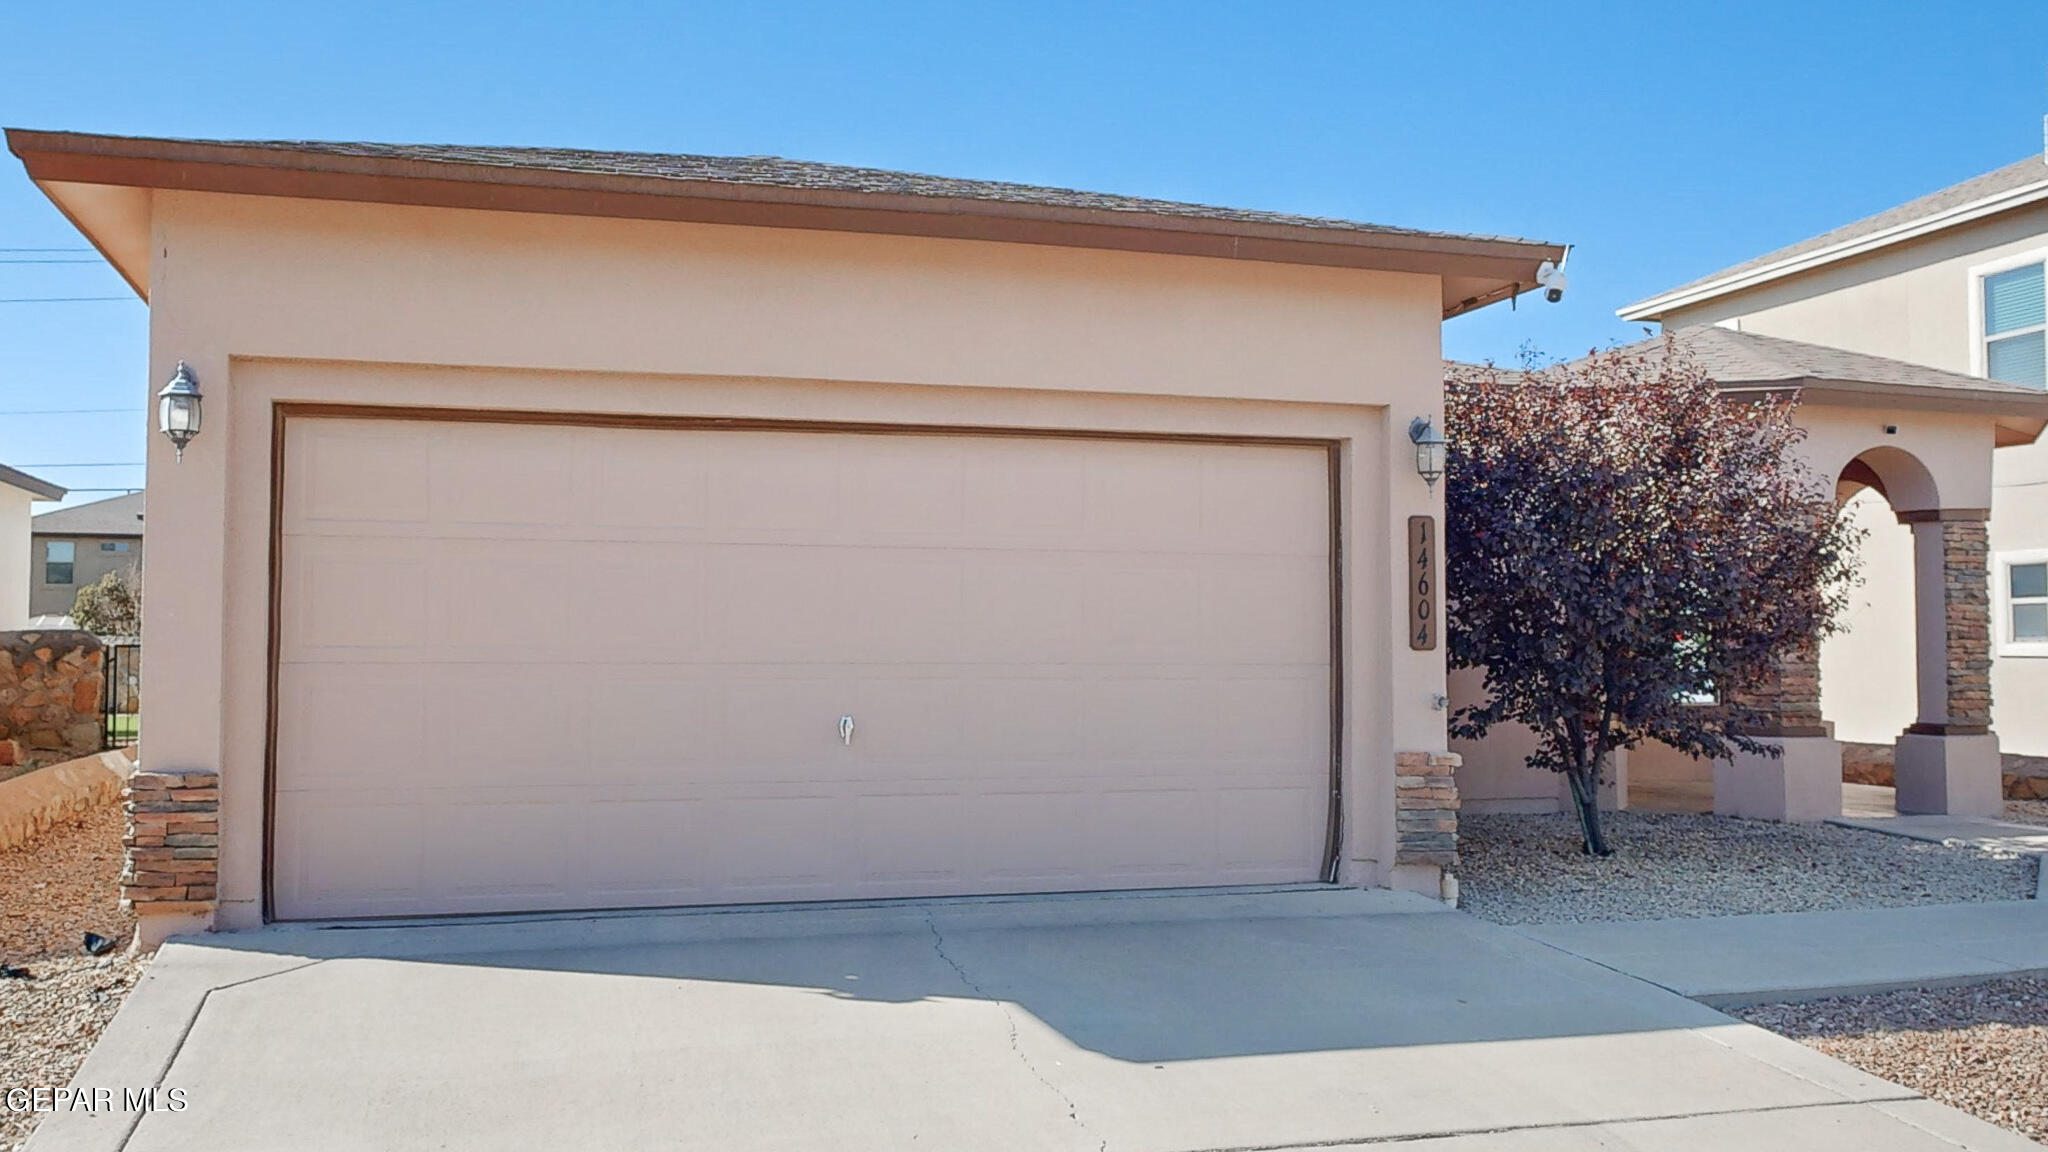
left=8, top=131, right=1563, bottom=935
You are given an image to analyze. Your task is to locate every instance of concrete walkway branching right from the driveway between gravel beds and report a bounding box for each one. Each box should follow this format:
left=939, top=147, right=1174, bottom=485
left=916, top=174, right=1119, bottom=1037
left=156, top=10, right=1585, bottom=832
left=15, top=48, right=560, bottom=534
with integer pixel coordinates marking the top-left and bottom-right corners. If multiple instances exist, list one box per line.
left=1513, top=900, right=2048, bottom=1006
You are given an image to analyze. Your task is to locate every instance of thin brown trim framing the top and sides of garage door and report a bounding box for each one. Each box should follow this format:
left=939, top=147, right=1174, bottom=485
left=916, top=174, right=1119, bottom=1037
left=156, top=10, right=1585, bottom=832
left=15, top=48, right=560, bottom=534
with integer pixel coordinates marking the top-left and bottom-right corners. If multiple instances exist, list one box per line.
left=262, top=402, right=1343, bottom=922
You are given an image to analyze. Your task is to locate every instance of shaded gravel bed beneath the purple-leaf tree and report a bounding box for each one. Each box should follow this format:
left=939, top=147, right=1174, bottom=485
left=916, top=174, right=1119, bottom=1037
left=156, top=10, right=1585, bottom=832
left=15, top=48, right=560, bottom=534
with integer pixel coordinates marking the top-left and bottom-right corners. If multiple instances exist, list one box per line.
left=1458, top=812, right=2036, bottom=924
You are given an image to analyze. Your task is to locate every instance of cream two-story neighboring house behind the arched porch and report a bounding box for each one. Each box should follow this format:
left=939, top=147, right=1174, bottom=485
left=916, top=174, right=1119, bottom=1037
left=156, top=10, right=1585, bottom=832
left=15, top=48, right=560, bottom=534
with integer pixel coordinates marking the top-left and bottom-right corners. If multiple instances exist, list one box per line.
left=1620, top=156, right=2048, bottom=756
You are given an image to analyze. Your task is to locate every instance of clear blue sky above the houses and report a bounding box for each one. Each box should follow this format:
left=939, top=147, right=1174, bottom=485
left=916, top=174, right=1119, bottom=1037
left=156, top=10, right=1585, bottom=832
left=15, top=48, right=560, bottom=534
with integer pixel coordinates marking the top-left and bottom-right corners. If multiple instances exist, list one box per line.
left=0, top=0, right=2048, bottom=506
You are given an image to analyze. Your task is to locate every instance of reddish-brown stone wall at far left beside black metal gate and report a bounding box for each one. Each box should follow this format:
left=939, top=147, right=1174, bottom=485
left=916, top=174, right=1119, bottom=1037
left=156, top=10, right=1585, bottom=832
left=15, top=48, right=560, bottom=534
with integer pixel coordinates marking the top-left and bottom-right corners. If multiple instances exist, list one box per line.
left=0, top=631, right=104, bottom=763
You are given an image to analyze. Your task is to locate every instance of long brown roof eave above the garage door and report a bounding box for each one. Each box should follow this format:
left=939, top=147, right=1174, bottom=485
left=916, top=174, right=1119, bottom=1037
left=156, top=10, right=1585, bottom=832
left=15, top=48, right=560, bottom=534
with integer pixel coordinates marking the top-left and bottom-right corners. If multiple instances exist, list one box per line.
left=6, top=129, right=1565, bottom=316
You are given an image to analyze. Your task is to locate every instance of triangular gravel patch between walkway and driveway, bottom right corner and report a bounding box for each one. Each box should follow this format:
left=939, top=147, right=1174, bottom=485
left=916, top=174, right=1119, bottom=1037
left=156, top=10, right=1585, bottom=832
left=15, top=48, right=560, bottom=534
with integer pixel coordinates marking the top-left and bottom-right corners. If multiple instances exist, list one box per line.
left=1735, top=980, right=2048, bottom=1142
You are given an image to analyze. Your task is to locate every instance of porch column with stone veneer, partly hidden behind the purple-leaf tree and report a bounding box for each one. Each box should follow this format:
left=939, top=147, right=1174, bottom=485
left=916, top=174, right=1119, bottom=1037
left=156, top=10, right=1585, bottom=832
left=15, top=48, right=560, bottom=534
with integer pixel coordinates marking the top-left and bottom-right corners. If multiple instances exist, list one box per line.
left=1714, top=644, right=1841, bottom=820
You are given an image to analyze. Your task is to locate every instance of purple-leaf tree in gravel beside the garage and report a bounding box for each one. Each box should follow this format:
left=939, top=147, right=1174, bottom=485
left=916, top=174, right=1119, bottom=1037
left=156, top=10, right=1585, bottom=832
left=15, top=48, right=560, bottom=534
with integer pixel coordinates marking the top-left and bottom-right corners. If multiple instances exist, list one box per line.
left=1444, top=340, right=1858, bottom=857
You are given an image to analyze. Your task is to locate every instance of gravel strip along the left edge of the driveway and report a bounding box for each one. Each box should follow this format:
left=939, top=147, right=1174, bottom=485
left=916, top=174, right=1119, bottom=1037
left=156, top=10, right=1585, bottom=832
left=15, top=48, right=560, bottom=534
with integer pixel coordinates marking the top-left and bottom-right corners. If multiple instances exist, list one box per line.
left=0, top=804, right=143, bottom=1148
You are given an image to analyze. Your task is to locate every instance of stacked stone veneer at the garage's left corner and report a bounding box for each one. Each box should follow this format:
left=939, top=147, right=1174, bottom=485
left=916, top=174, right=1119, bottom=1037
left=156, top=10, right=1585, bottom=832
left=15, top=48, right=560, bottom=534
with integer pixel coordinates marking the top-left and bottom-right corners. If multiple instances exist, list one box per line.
left=121, top=769, right=221, bottom=949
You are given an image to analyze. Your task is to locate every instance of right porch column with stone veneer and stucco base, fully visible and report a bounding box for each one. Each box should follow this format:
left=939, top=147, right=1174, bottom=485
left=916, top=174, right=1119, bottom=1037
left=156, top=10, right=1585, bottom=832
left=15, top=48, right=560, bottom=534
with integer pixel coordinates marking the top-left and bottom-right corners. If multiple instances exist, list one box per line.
left=1894, top=508, right=2005, bottom=816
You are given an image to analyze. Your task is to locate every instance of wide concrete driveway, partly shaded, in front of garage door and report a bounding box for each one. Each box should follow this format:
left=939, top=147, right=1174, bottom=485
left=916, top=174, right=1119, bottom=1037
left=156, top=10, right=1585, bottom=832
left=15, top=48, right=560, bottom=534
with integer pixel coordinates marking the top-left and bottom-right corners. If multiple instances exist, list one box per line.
left=31, top=890, right=2034, bottom=1152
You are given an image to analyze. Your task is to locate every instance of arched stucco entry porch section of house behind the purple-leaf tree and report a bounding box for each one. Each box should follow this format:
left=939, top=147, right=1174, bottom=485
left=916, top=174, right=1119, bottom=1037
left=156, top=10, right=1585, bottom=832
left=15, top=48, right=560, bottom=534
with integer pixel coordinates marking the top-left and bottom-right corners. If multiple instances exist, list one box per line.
left=1450, top=326, right=2048, bottom=820
